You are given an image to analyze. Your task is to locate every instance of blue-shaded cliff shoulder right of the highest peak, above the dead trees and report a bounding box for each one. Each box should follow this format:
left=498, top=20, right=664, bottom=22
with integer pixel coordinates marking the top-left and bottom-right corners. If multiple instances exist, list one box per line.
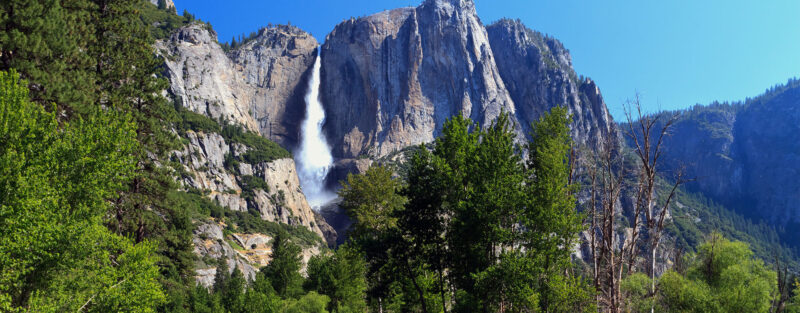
left=487, top=19, right=614, bottom=148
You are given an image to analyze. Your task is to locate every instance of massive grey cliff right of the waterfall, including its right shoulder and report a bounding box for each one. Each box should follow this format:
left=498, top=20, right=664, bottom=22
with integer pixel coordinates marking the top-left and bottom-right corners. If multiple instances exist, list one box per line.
left=321, top=0, right=613, bottom=159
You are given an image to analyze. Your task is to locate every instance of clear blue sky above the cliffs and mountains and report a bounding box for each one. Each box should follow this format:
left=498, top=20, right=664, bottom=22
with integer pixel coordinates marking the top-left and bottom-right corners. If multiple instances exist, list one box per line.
left=174, top=0, right=800, bottom=120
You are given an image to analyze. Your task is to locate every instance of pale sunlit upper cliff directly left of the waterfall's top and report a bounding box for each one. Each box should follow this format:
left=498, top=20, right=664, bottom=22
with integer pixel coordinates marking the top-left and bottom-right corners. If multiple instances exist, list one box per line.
left=157, top=23, right=317, bottom=147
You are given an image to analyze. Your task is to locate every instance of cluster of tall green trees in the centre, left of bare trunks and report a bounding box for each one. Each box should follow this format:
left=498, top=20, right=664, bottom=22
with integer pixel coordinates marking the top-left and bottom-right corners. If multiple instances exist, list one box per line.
left=339, top=108, right=595, bottom=312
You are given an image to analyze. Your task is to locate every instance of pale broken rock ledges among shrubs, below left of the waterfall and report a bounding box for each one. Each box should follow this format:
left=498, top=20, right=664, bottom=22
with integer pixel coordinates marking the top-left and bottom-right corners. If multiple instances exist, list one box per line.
left=173, top=131, right=336, bottom=286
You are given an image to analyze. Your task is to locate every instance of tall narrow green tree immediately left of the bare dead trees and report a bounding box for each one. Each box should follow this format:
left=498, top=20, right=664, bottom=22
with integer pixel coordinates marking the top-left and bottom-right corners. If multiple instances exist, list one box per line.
left=520, top=107, right=591, bottom=311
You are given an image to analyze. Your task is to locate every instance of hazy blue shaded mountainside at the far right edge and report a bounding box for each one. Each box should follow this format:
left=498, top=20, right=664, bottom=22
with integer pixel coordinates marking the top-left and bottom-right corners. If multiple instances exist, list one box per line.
left=640, top=80, right=800, bottom=227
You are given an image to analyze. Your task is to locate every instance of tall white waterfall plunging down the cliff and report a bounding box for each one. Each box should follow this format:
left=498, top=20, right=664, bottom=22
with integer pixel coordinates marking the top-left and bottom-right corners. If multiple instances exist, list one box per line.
left=294, top=56, right=336, bottom=210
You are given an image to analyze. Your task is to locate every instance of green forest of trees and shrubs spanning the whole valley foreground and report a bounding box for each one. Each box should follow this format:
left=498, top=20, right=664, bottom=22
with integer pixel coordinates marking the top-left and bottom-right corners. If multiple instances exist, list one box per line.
left=0, top=0, right=800, bottom=313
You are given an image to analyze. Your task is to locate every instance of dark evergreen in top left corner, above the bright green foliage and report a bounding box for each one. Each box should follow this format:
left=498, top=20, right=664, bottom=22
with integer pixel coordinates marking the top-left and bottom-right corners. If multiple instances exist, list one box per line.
left=0, top=0, right=97, bottom=113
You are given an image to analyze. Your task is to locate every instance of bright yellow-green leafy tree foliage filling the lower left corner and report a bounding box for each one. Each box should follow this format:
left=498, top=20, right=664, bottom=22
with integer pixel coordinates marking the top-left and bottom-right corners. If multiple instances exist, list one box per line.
left=0, top=71, right=164, bottom=312
